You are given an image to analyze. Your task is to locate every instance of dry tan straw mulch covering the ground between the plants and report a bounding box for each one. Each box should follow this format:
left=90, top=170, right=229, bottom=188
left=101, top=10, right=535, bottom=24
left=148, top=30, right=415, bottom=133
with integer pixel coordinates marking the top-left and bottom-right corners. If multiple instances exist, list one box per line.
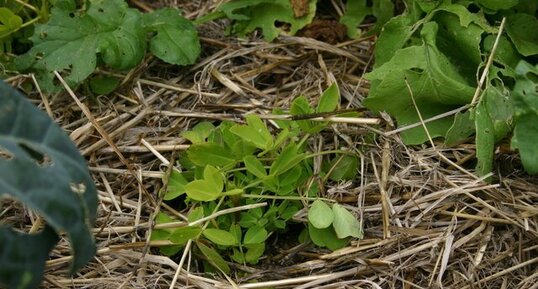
left=2, top=1, right=538, bottom=289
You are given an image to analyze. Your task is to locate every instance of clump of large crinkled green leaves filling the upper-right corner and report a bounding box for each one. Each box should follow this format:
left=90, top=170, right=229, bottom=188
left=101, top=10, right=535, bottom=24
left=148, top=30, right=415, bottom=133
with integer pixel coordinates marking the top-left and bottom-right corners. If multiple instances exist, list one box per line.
left=364, top=0, right=538, bottom=175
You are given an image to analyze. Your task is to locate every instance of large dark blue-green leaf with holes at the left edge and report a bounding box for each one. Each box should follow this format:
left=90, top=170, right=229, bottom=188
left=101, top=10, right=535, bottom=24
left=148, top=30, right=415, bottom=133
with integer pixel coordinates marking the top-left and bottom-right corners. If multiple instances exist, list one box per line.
left=0, top=82, right=97, bottom=282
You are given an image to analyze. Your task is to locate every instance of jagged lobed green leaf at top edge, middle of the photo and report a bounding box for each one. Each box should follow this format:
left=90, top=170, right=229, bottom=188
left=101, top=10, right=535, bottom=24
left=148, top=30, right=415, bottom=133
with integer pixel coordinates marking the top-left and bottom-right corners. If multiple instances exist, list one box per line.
left=218, top=0, right=317, bottom=42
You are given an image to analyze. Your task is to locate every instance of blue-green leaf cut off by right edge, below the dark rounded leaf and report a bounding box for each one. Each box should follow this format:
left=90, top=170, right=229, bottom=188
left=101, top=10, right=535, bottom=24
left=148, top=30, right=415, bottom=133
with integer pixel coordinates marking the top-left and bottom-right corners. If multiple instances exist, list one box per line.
left=512, top=61, right=538, bottom=174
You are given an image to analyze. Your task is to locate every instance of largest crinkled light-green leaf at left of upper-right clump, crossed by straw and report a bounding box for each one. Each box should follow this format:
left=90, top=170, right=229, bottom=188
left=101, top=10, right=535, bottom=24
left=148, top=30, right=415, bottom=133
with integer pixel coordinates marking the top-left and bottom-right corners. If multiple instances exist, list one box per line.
left=364, top=22, right=475, bottom=144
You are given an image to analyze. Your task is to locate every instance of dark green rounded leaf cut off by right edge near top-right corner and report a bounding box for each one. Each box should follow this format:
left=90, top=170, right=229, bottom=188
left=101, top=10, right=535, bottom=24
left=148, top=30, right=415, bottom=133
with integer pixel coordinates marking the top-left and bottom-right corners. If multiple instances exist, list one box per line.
left=506, top=13, right=538, bottom=56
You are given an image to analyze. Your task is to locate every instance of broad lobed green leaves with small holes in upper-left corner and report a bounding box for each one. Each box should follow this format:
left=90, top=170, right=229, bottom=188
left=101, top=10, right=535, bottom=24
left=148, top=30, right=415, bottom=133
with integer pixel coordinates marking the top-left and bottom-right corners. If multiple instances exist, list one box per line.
left=0, top=0, right=201, bottom=94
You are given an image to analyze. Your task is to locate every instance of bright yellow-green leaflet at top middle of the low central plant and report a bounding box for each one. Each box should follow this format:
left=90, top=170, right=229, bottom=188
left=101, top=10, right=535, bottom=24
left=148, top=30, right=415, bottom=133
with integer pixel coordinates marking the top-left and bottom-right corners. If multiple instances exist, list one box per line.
left=230, top=115, right=273, bottom=150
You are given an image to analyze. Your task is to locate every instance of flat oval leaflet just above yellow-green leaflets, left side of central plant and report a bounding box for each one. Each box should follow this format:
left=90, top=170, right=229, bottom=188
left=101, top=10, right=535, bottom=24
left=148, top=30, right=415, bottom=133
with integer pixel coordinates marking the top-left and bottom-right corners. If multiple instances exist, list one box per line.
left=187, top=143, right=235, bottom=167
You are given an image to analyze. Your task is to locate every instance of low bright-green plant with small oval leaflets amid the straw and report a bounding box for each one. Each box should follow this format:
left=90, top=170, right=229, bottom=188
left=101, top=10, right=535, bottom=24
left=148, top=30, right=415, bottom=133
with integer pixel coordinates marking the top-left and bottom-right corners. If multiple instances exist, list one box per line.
left=152, top=84, right=362, bottom=272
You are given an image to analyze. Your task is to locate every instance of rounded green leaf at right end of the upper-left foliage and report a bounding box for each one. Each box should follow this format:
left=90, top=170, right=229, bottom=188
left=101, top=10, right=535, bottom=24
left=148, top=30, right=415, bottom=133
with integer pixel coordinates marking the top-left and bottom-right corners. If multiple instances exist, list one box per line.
left=142, top=8, right=201, bottom=65
